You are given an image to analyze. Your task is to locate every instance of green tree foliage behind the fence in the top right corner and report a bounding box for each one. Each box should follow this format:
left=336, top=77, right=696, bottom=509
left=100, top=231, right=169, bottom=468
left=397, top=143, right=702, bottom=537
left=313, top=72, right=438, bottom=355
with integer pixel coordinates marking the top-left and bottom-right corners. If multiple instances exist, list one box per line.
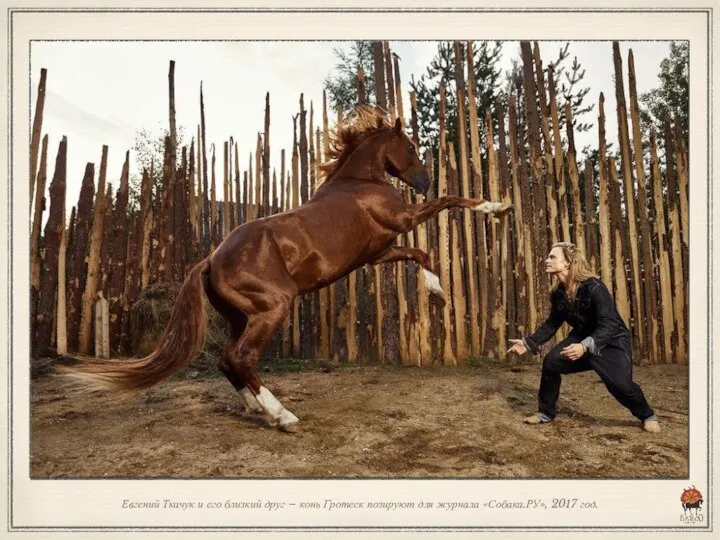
left=640, top=41, right=690, bottom=147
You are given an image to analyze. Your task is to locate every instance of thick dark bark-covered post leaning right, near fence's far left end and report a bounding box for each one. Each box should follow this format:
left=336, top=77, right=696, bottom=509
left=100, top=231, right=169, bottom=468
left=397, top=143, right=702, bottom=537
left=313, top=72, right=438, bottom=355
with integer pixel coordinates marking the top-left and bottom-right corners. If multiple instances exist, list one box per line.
left=32, top=137, right=67, bottom=358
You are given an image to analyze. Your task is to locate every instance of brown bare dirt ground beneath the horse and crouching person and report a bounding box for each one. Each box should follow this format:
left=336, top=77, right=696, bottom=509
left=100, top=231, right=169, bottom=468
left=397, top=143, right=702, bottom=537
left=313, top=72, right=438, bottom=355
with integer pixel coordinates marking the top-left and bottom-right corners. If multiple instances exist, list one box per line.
left=31, top=363, right=688, bottom=478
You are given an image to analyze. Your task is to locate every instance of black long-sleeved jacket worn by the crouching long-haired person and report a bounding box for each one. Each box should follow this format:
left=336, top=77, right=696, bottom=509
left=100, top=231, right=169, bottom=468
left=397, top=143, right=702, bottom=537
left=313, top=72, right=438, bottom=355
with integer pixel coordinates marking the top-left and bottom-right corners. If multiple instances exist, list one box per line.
left=524, top=277, right=630, bottom=354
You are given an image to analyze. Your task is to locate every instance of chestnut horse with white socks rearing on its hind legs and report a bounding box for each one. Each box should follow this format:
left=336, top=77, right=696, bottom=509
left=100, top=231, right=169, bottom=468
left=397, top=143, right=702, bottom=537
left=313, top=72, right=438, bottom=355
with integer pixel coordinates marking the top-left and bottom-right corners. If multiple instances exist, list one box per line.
left=64, top=107, right=510, bottom=431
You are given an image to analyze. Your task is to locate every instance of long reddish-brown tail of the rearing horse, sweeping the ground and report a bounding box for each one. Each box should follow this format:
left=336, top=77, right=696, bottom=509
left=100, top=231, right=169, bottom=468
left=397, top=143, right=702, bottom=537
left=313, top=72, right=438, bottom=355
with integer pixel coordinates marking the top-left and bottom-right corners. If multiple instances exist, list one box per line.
left=60, top=259, right=210, bottom=391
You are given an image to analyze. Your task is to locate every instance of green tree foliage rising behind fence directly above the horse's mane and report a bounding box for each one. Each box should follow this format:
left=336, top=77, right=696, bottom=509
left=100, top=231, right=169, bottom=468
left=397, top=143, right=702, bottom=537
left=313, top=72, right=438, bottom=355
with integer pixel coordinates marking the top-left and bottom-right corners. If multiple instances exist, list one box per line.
left=323, top=41, right=375, bottom=114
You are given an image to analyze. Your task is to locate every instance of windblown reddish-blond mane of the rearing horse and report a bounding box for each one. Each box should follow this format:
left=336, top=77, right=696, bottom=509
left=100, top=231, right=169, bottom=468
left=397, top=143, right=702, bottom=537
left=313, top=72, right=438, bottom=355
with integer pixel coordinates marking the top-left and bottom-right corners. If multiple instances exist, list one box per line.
left=318, top=105, right=392, bottom=184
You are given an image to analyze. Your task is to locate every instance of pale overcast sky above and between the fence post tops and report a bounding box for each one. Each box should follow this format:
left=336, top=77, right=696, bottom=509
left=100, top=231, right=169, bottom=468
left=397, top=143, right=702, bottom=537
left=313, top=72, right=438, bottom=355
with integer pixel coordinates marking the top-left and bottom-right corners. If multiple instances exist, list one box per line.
left=28, top=41, right=669, bottom=216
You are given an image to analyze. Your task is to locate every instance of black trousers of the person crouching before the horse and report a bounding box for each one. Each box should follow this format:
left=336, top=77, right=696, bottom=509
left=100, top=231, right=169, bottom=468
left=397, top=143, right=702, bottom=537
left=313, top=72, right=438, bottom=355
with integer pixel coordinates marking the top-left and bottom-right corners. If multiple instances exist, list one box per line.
left=538, top=333, right=655, bottom=420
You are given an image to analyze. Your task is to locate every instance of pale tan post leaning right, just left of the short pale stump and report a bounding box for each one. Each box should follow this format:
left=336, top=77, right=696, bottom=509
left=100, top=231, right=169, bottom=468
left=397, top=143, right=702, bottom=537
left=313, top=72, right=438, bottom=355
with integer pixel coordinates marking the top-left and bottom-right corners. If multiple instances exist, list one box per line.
left=78, top=146, right=108, bottom=354
